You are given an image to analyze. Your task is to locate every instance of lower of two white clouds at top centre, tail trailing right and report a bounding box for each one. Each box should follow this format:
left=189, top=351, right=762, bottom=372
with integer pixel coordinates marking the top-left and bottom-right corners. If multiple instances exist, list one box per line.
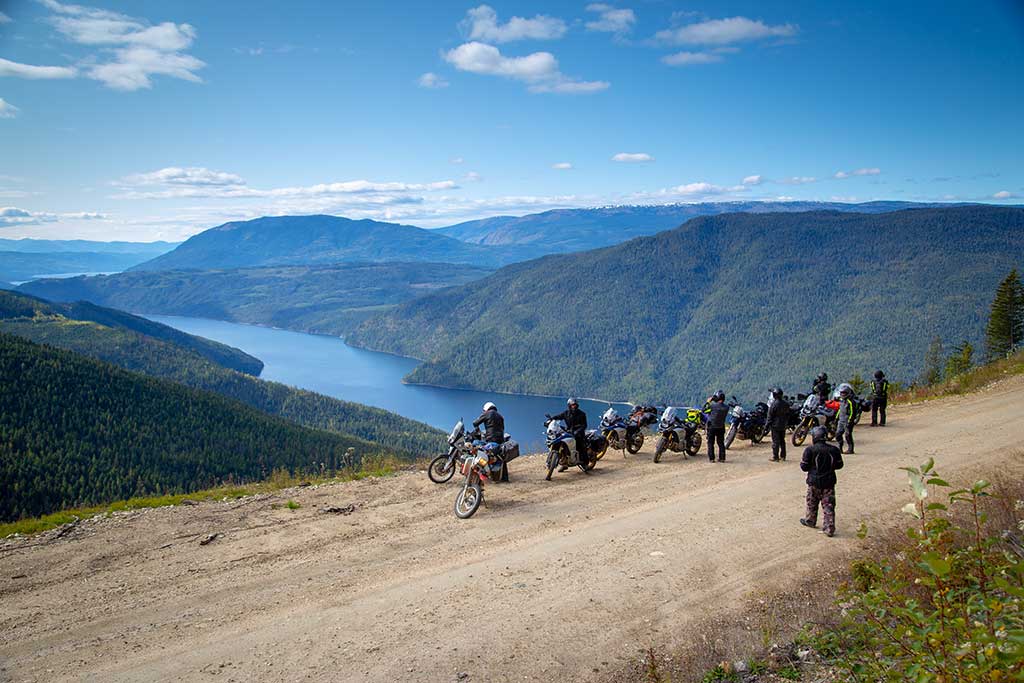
left=444, top=41, right=609, bottom=94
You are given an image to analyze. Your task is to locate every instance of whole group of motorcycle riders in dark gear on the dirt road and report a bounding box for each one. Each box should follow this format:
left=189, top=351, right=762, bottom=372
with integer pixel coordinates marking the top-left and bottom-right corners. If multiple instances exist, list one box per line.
left=473, top=370, right=889, bottom=537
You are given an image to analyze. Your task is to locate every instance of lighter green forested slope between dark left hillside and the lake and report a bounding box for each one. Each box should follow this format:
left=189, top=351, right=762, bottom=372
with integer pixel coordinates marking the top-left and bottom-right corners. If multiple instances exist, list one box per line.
left=0, top=293, right=442, bottom=458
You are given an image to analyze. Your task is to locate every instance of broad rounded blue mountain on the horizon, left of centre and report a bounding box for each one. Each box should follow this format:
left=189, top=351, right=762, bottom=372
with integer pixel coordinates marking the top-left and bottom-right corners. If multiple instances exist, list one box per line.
left=132, top=215, right=516, bottom=270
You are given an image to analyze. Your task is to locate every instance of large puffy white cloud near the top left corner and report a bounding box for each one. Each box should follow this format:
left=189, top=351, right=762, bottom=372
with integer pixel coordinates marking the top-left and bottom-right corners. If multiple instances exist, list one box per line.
left=40, top=0, right=206, bottom=91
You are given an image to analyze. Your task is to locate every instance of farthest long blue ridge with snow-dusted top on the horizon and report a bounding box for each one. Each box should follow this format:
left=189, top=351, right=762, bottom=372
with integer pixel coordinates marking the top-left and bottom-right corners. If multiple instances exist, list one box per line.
left=437, top=201, right=954, bottom=257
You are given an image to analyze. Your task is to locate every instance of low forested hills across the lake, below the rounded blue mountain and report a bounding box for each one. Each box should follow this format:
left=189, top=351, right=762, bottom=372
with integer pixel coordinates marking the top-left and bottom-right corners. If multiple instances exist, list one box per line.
left=20, top=263, right=490, bottom=335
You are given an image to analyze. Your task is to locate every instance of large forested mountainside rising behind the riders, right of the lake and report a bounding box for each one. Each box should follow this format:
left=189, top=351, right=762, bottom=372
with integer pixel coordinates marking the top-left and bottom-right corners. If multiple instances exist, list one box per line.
left=348, top=206, right=1024, bottom=402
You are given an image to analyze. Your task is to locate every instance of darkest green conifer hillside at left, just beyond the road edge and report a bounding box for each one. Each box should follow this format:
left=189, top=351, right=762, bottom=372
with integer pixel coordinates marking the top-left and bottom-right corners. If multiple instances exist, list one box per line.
left=0, top=333, right=379, bottom=521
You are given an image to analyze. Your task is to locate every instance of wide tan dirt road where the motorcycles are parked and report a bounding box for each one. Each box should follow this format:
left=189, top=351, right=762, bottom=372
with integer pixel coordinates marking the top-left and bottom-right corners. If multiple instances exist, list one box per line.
left=0, top=378, right=1024, bottom=681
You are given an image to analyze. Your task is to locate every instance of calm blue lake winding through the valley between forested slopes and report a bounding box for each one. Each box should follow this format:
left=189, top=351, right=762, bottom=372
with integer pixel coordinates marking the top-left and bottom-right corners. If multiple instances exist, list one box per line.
left=146, top=315, right=627, bottom=449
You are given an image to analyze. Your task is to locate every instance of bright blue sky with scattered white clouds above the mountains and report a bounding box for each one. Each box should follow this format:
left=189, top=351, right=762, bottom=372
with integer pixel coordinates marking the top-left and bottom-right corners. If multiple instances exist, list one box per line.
left=0, top=0, right=1024, bottom=240
